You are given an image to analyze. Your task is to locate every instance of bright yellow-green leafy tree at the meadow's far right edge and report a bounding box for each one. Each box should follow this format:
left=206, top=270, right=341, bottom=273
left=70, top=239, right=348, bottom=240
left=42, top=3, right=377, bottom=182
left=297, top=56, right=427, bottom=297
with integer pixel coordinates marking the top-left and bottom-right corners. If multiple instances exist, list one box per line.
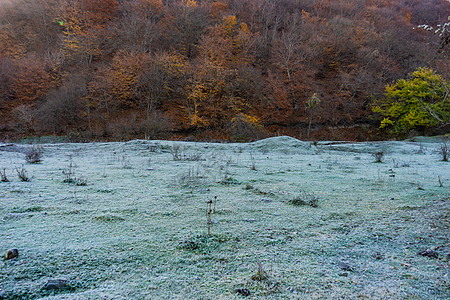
left=373, top=68, right=450, bottom=134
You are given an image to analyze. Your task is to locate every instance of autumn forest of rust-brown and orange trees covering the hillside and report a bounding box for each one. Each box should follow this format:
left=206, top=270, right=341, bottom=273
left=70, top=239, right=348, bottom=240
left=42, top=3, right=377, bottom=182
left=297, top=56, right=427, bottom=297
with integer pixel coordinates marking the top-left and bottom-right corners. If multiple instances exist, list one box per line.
left=0, top=0, right=450, bottom=141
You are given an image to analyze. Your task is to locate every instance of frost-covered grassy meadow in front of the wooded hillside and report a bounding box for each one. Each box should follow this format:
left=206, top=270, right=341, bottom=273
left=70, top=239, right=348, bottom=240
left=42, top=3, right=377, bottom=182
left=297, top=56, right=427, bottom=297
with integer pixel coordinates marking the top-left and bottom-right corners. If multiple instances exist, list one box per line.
left=0, top=137, right=450, bottom=299
